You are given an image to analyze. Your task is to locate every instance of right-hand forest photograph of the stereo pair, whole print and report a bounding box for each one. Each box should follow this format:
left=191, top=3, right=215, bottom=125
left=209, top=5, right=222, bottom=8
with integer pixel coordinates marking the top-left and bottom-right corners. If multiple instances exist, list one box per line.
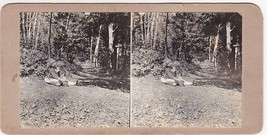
left=131, top=12, right=242, bottom=128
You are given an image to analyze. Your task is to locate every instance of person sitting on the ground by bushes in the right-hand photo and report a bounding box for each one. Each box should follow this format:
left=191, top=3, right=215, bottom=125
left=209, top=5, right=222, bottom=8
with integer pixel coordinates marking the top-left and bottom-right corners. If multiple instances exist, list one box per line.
left=161, top=59, right=193, bottom=86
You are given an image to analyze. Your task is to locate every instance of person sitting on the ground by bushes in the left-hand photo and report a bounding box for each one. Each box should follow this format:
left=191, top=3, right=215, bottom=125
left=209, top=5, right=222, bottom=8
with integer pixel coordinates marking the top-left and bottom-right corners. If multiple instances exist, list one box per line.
left=45, top=58, right=77, bottom=86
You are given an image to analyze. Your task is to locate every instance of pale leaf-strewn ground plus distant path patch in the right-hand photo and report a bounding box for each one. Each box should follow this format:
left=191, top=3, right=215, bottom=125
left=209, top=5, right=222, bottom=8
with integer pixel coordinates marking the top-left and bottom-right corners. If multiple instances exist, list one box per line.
left=132, top=63, right=242, bottom=127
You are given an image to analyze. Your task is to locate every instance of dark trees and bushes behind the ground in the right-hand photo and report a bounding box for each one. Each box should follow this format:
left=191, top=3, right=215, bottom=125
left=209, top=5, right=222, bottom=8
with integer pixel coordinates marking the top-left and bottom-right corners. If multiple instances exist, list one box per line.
left=132, top=12, right=242, bottom=85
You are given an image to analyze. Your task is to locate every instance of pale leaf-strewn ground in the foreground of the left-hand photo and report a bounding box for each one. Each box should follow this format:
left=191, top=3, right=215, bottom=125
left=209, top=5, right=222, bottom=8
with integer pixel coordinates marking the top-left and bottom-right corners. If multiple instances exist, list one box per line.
left=21, top=76, right=129, bottom=128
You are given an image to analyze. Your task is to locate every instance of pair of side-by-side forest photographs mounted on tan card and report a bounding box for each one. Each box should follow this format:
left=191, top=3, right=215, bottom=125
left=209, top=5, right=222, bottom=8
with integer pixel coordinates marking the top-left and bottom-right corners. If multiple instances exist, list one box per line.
left=20, top=12, right=242, bottom=128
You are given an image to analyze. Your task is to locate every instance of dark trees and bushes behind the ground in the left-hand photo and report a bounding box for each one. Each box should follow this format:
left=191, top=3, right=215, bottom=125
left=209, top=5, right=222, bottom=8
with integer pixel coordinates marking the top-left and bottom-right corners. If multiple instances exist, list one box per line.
left=20, top=12, right=130, bottom=90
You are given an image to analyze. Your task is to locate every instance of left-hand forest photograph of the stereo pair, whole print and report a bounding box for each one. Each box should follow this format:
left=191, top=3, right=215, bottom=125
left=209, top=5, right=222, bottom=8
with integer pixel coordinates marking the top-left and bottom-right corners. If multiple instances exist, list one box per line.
left=20, top=12, right=130, bottom=127
